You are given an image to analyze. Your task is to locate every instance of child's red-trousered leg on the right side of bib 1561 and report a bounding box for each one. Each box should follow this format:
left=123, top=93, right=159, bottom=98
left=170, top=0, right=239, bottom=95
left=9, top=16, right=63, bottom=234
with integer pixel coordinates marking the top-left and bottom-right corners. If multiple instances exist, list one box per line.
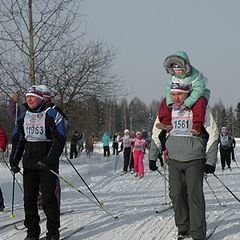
left=192, top=97, right=208, bottom=134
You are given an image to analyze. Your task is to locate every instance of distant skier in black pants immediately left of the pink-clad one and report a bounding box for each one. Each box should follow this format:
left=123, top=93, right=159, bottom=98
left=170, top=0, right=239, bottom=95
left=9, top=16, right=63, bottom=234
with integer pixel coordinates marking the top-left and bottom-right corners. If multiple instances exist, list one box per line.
left=119, top=129, right=133, bottom=175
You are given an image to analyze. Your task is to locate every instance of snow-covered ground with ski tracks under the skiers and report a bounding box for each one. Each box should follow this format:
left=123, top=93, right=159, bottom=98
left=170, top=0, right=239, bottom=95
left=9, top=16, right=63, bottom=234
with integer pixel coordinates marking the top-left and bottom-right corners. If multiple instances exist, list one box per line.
left=0, top=139, right=240, bottom=240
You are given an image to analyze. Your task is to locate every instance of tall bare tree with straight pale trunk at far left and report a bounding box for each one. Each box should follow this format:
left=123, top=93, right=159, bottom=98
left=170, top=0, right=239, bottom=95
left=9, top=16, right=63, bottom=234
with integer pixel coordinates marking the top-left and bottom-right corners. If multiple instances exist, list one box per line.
left=0, top=0, right=81, bottom=88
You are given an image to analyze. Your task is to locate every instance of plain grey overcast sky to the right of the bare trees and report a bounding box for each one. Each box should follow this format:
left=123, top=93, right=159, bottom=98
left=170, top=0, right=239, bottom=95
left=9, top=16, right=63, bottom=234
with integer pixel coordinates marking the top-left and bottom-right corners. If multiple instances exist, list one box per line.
left=81, top=0, right=240, bottom=107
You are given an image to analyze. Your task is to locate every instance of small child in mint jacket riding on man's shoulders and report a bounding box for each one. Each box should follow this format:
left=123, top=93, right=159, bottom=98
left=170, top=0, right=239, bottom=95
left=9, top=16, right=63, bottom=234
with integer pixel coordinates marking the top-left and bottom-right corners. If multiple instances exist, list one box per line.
left=159, top=51, right=210, bottom=135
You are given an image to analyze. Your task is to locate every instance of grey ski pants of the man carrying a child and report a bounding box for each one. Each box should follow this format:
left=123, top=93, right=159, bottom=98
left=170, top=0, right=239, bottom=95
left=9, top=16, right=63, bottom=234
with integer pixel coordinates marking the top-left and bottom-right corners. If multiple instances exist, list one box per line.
left=169, top=159, right=206, bottom=240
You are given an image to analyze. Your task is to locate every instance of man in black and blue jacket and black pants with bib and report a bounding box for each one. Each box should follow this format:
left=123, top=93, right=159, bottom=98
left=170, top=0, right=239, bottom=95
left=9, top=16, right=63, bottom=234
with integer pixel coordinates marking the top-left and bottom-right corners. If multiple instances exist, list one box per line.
left=10, top=85, right=66, bottom=240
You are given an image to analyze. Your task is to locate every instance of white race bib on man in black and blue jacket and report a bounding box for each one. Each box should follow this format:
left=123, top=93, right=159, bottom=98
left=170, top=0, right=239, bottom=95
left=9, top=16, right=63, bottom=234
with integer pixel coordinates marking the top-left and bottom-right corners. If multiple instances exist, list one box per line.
left=23, top=109, right=51, bottom=142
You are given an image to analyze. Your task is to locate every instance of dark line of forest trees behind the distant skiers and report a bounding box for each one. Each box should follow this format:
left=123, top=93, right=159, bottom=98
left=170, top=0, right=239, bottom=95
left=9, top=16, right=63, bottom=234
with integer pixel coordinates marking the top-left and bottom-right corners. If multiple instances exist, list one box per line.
left=0, top=96, right=240, bottom=142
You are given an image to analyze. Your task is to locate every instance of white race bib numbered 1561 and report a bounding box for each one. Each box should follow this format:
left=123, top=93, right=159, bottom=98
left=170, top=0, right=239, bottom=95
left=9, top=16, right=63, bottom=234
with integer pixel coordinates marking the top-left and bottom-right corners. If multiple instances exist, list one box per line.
left=170, top=109, right=193, bottom=136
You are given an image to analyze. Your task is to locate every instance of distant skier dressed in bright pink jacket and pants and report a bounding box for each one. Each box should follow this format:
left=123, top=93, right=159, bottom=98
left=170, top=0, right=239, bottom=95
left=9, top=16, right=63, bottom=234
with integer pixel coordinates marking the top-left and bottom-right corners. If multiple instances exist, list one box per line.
left=131, top=132, right=148, bottom=178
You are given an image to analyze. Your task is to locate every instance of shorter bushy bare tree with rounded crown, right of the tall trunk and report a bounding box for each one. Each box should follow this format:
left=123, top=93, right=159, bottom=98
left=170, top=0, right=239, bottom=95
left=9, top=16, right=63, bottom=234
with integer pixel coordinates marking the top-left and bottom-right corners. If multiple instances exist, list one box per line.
left=45, top=41, right=121, bottom=112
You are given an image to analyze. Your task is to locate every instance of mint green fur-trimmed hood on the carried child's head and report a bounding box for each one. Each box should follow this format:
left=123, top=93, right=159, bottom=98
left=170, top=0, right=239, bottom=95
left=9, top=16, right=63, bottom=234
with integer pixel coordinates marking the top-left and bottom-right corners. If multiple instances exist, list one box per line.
left=164, top=51, right=192, bottom=76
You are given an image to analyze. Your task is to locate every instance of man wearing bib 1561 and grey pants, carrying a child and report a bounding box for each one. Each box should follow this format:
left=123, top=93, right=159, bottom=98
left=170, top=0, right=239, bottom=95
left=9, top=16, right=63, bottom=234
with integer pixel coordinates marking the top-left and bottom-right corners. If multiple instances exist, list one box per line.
left=151, top=82, right=218, bottom=240
